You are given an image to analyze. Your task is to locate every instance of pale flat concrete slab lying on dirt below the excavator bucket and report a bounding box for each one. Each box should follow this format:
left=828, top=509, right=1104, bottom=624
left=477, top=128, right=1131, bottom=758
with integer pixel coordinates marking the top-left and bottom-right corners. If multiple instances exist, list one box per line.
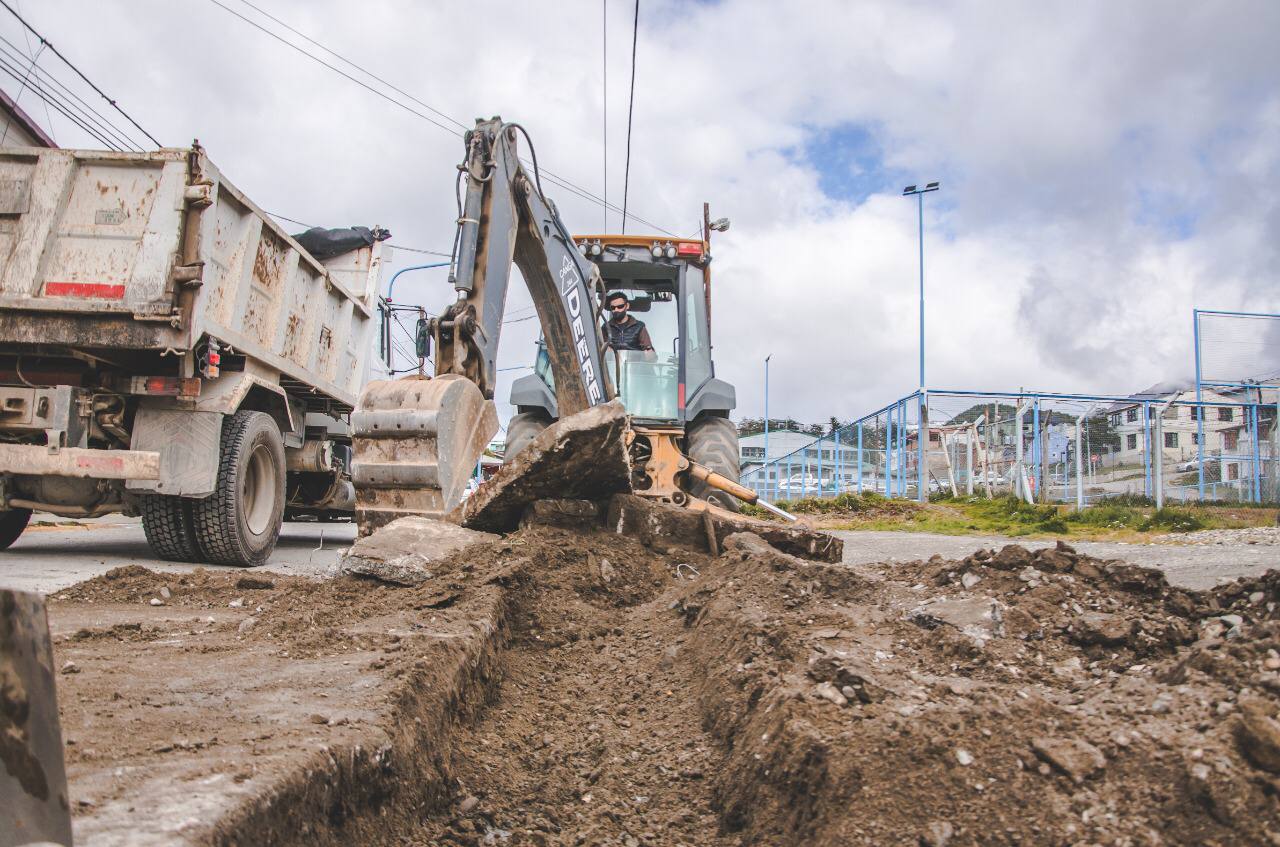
left=328, top=517, right=498, bottom=585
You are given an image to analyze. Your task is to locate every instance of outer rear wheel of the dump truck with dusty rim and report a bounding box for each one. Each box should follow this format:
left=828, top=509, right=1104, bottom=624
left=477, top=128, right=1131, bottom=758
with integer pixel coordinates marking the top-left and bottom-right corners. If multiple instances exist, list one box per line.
left=191, top=412, right=284, bottom=568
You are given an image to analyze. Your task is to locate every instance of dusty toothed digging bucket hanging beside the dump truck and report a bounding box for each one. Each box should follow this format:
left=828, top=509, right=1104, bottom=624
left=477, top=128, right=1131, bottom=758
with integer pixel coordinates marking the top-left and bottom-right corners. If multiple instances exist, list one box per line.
left=351, top=374, right=498, bottom=535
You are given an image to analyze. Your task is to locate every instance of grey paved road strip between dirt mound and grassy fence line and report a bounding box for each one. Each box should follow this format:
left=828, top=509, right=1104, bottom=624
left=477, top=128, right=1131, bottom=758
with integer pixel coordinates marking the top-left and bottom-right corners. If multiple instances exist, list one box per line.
left=835, top=530, right=1280, bottom=589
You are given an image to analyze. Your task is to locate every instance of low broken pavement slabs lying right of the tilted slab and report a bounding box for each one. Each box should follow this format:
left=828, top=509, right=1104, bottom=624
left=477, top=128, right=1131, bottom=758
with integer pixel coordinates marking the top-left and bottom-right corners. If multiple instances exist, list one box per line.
left=607, top=494, right=845, bottom=562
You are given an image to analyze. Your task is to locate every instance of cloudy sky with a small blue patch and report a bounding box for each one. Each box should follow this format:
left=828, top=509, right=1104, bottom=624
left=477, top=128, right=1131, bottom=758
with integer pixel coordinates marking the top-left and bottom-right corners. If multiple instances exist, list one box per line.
left=0, top=0, right=1280, bottom=432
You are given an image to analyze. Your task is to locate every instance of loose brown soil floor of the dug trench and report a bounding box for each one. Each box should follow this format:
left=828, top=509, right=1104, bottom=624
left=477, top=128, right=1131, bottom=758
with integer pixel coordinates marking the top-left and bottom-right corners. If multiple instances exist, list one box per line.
left=404, top=532, right=742, bottom=847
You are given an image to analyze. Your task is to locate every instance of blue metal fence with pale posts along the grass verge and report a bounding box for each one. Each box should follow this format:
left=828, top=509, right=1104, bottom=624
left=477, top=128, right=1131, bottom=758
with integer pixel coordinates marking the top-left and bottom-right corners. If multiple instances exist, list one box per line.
left=741, top=385, right=1280, bottom=507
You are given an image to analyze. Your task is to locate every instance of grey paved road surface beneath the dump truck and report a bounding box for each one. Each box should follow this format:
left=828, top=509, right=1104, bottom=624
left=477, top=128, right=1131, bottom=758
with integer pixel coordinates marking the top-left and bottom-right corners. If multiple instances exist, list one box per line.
left=0, top=514, right=356, bottom=594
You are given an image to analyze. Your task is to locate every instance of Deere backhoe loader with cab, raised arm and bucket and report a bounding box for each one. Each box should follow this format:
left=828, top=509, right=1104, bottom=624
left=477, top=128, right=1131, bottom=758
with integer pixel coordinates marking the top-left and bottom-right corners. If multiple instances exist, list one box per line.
left=352, top=118, right=756, bottom=535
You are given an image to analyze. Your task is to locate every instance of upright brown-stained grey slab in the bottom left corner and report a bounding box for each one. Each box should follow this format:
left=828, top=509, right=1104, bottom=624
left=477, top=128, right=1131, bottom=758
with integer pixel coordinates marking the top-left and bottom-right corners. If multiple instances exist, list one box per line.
left=0, top=590, right=72, bottom=847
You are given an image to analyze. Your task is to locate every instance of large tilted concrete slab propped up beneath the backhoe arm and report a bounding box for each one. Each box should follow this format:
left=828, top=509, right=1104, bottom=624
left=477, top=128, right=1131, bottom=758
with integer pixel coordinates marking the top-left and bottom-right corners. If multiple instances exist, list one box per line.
left=445, top=400, right=631, bottom=532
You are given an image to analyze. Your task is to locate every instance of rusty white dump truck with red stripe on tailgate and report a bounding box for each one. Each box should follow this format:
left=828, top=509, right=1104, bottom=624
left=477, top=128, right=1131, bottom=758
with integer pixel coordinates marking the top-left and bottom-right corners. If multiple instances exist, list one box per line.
left=0, top=145, right=383, bottom=566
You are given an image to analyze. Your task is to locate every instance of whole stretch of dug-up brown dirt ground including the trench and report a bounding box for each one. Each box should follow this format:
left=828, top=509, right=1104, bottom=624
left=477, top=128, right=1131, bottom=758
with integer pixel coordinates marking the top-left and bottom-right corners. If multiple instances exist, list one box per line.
left=50, top=514, right=1280, bottom=847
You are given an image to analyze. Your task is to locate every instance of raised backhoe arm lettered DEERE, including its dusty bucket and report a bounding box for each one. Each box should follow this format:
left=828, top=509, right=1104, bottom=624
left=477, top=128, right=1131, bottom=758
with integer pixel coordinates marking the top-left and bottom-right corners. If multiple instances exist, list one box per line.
left=352, top=118, right=614, bottom=535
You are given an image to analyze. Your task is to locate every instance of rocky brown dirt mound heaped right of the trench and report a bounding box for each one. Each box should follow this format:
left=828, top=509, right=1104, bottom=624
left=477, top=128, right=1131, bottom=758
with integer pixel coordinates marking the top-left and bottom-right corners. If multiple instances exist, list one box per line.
left=682, top=546, right=1280, bottom=844
